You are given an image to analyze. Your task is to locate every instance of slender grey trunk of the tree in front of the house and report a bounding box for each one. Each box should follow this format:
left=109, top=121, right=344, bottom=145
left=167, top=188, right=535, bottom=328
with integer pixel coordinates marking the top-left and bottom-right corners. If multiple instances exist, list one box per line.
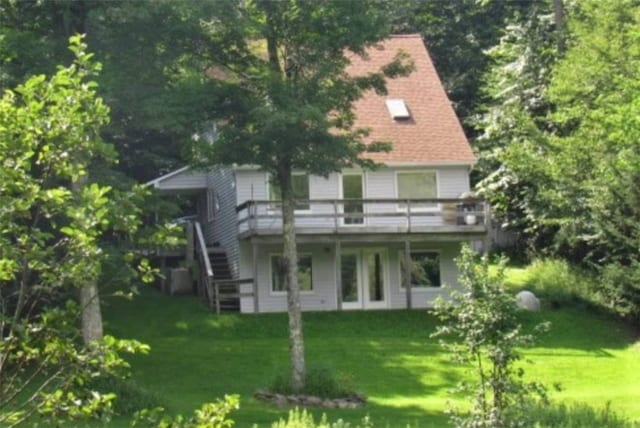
left=278, top=168, right=305, bottom=392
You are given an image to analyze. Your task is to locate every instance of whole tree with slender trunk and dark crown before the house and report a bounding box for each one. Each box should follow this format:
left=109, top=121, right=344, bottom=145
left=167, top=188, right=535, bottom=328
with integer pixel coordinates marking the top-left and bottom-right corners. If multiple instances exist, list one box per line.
left=198, top=0, right=410, bottom=390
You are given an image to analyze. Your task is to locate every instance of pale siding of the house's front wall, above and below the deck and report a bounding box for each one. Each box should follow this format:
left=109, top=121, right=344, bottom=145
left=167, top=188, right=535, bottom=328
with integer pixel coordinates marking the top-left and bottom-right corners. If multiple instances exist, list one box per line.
left=235, top=166, right=469, bottom=312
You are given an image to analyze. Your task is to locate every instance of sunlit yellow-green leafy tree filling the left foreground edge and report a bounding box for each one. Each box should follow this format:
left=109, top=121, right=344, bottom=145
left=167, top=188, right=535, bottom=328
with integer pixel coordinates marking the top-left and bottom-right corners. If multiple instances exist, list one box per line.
left=0, top=37, right=148, bottom=426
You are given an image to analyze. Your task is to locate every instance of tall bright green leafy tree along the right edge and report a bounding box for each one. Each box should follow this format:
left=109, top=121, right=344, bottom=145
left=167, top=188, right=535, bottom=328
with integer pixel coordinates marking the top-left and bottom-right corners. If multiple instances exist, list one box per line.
left=547, top=0, right=640, bottom=320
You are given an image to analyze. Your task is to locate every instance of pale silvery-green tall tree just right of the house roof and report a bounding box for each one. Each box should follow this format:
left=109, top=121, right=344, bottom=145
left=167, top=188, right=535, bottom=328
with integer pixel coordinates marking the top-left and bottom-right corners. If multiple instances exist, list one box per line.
left=474, top=1, right=558, bottom=251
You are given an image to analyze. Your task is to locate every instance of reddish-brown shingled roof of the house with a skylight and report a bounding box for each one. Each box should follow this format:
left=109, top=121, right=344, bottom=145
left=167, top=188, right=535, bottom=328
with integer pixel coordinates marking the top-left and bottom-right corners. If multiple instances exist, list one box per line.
left=348, top=34, right=476, bottom=165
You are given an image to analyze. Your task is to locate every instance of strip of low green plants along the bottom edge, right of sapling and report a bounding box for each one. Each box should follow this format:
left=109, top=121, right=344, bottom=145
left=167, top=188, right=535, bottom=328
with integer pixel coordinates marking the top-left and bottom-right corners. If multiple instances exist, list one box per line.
left=525, top=403, right=632, bottom=428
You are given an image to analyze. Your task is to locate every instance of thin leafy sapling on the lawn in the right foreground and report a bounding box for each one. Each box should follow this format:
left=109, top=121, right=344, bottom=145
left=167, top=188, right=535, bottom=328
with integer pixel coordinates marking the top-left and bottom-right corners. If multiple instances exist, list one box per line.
left=434, top=246, right=548, bottom=428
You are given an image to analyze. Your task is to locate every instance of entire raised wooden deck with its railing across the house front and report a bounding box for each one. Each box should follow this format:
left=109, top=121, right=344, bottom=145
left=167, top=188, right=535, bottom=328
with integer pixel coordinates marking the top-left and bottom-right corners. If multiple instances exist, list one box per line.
left=236, top=199, right=491, bottom=242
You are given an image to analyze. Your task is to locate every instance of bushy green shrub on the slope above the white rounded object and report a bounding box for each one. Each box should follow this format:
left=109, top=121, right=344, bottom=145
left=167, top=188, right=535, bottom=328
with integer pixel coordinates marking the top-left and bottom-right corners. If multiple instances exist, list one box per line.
left=526, top=259, right=597, bottom=307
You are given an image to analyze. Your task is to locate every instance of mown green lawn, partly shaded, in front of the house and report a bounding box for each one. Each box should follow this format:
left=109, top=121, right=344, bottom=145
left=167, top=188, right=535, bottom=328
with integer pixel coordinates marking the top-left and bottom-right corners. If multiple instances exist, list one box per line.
left=105, top=289, right=640, bottom=427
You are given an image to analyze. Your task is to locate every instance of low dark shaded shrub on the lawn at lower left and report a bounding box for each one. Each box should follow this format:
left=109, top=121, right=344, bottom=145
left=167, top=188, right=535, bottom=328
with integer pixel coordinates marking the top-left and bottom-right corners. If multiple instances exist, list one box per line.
left=88, top=376, right=161, bottom=415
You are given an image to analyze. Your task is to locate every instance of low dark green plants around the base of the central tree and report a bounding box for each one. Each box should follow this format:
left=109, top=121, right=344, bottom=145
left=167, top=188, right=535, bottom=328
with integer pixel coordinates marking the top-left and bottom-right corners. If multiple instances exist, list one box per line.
left=269, top=366, right=354, bottom=398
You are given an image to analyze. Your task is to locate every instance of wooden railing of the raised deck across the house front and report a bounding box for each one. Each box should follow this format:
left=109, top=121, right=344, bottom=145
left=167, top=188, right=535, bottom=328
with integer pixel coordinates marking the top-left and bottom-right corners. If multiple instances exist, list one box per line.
left=236, top=198, right=490, bottom=234
